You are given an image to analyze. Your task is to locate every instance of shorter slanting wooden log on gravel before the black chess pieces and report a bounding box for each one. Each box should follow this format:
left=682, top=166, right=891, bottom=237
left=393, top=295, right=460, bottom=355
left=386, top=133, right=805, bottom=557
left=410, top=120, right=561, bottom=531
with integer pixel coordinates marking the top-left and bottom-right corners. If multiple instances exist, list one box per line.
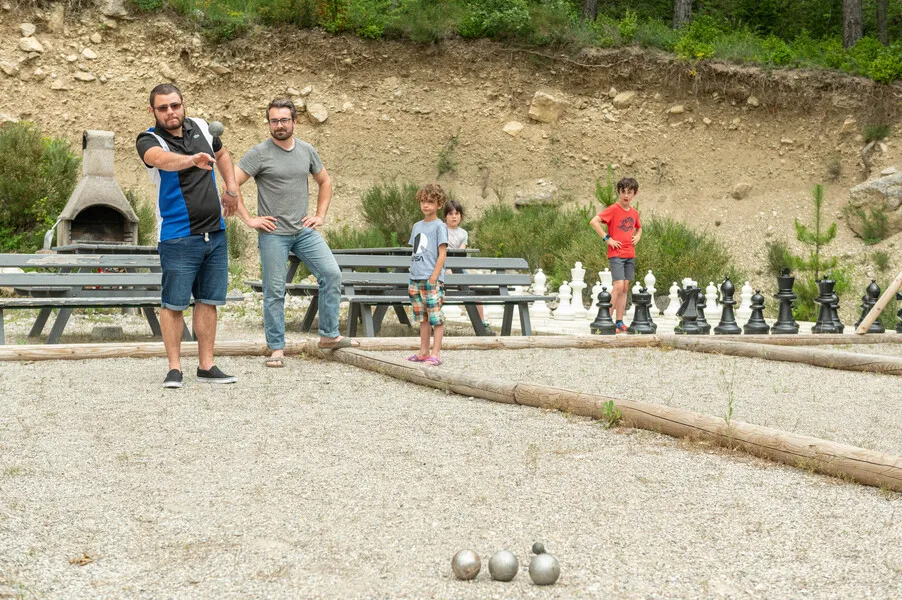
left=663, top=336, right=902, bottom=375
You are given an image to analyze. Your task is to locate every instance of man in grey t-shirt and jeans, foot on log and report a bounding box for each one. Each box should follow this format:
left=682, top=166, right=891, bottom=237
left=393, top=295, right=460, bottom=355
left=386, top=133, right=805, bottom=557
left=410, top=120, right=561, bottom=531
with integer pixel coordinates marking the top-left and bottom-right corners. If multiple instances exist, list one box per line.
left=235, top=99, right=358, bottom=367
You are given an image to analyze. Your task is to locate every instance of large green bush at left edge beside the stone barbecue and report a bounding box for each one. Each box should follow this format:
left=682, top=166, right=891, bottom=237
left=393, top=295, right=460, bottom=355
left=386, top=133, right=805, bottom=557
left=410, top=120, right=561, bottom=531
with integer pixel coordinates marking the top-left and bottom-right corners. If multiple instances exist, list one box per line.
left=0, top=122, right=80, bottom=252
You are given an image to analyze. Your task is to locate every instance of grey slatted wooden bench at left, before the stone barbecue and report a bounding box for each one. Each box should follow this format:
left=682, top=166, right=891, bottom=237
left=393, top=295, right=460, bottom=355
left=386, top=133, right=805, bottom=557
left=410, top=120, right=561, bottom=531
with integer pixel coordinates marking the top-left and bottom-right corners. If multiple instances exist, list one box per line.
left=0, top=254, right=242, bottom=344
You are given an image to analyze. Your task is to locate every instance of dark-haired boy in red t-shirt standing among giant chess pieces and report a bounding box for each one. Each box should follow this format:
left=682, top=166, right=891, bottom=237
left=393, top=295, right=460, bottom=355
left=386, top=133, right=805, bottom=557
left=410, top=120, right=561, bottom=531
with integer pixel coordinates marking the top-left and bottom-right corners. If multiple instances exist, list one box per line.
left=589, top=177, right=642, bottom=333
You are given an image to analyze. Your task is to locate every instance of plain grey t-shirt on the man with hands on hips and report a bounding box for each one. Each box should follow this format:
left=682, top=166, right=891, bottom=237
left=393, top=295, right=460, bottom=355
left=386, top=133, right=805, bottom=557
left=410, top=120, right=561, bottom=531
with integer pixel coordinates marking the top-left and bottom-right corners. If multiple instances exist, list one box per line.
left=238, top=138, right=323, bottom=235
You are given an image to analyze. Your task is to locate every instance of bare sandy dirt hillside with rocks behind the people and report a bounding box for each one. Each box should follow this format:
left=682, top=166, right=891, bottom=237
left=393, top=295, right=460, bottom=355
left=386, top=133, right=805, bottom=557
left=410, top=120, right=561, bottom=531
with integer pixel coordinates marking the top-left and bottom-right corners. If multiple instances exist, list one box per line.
left=0, top=4, right=902, bottom=285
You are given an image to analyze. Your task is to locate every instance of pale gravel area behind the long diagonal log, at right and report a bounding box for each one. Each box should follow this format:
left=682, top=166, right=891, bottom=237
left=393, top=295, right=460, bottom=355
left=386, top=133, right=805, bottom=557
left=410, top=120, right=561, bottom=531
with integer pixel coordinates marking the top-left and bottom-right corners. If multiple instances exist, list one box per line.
left=448, top=344, right=902, bottom=455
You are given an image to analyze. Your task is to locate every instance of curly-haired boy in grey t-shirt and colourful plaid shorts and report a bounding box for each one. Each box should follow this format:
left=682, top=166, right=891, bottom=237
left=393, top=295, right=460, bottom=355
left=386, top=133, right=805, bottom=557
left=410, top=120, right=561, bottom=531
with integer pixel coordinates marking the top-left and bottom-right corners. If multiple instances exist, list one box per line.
left=407, top=183, right=448, bottom=366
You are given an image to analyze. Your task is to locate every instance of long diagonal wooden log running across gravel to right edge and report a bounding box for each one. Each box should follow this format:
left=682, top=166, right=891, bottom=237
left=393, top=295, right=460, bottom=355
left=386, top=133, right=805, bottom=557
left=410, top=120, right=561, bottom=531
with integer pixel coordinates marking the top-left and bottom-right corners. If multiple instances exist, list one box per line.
left=317, top=349, right=902, bottom=491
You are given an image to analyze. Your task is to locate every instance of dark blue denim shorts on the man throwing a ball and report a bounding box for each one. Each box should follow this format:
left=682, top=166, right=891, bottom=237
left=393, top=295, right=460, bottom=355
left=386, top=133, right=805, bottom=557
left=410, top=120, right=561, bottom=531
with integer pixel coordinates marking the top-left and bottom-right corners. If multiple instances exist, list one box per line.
left=157, top=231, right=229, bottom=310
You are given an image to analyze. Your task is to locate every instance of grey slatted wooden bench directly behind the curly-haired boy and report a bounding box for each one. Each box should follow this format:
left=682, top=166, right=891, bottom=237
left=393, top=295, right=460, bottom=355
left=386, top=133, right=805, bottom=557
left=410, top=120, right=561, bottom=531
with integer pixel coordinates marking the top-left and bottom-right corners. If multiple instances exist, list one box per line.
left=245, top=250, right=552, bottom=337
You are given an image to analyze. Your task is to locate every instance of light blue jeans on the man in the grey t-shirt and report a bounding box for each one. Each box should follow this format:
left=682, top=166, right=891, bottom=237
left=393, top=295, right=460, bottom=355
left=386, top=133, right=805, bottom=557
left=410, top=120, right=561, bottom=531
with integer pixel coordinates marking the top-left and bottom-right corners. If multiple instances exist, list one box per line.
left=257, top=227, right=341, bottom=350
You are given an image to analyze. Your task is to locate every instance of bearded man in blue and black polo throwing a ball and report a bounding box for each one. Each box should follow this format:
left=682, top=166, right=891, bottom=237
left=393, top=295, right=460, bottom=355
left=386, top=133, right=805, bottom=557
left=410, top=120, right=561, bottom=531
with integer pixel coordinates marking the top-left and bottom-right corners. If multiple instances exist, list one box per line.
left=136, top=83, right=238, bottom=388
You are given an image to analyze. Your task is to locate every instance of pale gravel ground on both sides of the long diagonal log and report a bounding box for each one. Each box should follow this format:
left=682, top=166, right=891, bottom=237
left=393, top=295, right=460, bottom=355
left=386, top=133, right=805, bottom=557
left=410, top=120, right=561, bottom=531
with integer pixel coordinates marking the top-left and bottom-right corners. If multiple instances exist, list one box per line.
left=0, top=350, right=902, bottom=599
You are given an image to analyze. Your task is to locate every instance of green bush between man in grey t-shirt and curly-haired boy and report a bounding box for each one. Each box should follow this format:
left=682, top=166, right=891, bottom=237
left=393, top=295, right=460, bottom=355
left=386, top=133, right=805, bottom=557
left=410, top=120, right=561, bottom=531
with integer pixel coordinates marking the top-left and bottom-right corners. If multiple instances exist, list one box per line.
left=360, top=181, right=423, bottom=245
